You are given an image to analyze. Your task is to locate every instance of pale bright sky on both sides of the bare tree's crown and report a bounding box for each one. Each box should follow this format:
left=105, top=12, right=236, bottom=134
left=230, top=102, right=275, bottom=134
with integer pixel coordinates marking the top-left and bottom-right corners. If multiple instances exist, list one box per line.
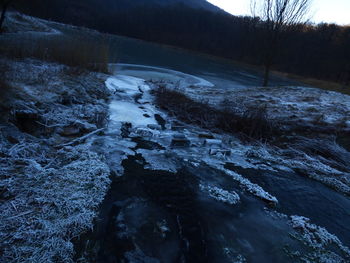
left=208, top=0, right=350, bottom=25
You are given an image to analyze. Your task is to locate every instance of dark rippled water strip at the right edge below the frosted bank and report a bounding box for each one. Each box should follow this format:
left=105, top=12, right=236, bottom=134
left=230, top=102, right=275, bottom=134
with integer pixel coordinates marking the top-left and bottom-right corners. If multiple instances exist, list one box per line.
left=227, top=164, right=350, bottom=249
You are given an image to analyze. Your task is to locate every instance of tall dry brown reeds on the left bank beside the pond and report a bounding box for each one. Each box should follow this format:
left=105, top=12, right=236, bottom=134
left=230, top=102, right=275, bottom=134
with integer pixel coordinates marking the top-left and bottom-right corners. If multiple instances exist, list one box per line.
left=0, top=34, right=109, bottom=73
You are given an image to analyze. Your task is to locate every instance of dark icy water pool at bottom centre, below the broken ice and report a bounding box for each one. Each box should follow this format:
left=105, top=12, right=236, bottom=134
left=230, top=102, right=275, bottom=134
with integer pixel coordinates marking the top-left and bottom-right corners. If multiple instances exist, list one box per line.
left=83, top=156, right=298, bottom=263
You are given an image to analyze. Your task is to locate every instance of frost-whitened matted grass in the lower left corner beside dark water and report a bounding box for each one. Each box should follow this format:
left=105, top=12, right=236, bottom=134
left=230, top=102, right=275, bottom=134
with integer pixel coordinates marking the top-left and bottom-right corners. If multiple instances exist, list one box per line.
left=0, top=142, right=109, bottom=262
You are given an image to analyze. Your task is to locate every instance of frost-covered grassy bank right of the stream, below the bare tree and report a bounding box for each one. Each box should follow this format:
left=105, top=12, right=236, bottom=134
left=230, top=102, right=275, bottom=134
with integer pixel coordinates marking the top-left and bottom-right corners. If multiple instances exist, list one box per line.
left=151, top=78, right=350, bottom=198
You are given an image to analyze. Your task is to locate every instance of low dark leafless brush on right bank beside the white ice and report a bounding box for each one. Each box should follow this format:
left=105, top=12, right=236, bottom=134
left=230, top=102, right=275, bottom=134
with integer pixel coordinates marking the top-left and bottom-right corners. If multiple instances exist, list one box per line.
left=154, top=86, right=279, bottom=141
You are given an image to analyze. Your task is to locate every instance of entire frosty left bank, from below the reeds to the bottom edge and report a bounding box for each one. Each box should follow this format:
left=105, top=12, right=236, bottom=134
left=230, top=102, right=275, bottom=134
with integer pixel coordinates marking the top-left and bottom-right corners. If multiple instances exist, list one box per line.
left=0, top=58, right=110, bottom=263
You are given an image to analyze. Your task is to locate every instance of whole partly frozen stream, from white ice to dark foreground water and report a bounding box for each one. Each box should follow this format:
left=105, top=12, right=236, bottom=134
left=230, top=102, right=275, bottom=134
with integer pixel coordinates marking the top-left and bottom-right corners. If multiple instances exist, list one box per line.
left=79, top=64, right=350, bottom=263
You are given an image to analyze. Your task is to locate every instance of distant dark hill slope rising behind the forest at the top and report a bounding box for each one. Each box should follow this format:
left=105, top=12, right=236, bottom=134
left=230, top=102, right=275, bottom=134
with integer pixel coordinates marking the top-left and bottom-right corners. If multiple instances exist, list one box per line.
left=14, top=0, right=221, bottom=25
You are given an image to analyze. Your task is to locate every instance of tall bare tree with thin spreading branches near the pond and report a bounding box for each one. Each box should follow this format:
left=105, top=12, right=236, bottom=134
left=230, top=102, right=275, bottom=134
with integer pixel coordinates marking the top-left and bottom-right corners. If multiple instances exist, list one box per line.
left=251, top=0, right=312, bottom=86
